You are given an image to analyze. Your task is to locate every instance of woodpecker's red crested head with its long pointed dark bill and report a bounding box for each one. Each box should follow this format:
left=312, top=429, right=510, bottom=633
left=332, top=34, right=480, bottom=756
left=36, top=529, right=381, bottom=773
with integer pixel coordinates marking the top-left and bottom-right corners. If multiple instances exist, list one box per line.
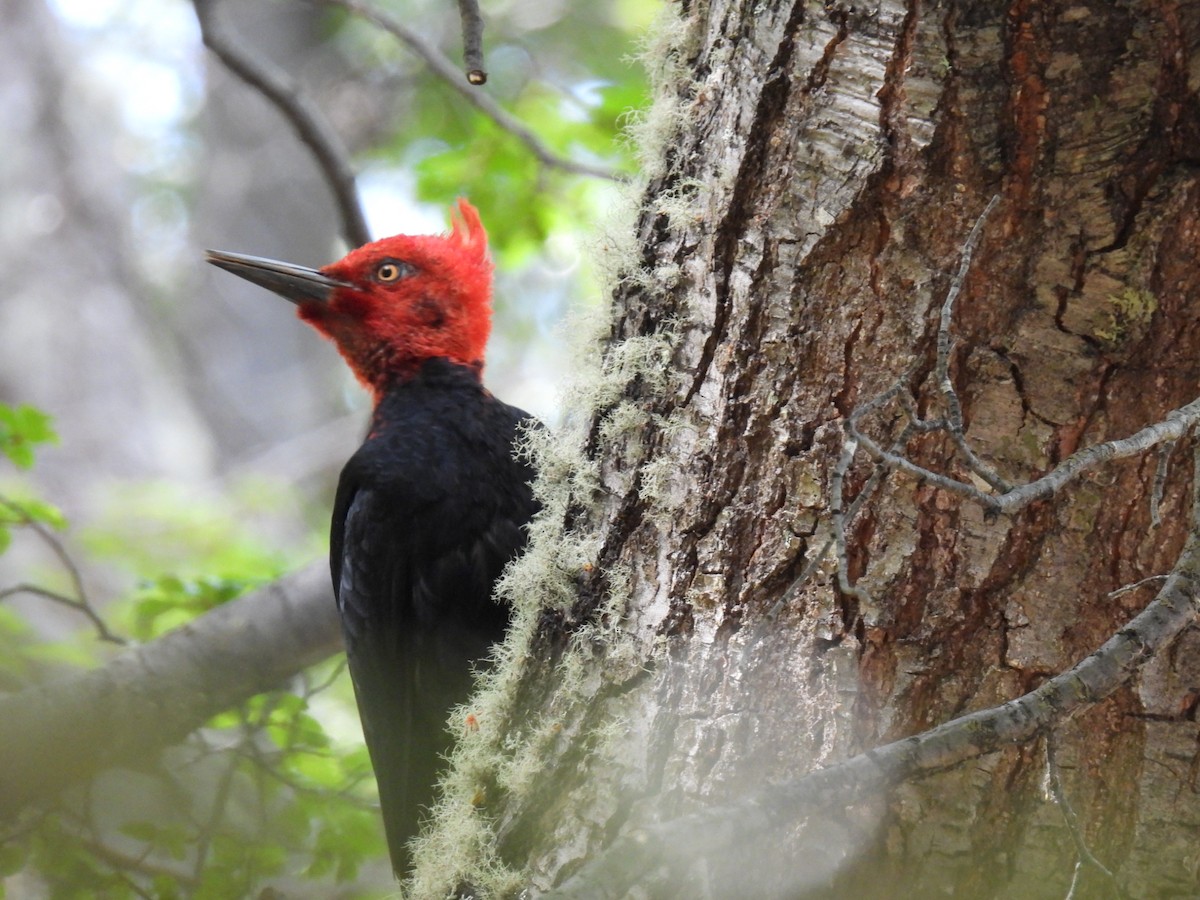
left=209, top=199, right=492, bottom=400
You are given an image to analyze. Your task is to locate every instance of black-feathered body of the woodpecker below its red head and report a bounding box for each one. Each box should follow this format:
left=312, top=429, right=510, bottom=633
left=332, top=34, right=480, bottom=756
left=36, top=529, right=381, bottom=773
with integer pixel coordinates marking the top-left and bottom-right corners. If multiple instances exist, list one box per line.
left=330, top=359, right=535, bottom=874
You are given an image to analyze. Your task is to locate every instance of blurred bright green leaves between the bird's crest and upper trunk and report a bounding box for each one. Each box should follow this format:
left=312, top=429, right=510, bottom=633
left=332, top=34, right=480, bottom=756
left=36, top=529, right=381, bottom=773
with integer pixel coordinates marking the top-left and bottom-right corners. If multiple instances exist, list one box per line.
left=330, top=4, right=654, bottom=268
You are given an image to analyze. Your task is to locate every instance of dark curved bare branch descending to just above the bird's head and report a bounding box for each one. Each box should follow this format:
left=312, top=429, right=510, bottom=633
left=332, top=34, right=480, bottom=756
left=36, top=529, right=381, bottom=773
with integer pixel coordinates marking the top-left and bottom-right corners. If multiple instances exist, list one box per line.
left=192, top=0, right=371, bottom=247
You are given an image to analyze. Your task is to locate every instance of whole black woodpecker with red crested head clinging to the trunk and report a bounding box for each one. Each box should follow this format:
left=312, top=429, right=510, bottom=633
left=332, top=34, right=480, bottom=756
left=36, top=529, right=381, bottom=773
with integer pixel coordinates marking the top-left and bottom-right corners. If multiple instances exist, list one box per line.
left=208, top=200, right=536, bottom=877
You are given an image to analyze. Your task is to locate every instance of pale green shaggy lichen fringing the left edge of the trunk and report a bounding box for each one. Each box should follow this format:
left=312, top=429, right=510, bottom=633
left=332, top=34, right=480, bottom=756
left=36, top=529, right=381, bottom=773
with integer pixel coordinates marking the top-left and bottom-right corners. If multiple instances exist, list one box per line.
left=404, top=8, right=700, bottom=898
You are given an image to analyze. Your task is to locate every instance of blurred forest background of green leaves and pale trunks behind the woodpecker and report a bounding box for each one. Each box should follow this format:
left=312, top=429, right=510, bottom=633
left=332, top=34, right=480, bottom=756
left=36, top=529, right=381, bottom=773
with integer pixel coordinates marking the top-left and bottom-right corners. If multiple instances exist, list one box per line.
left=0, top=0, right=658, bottom=898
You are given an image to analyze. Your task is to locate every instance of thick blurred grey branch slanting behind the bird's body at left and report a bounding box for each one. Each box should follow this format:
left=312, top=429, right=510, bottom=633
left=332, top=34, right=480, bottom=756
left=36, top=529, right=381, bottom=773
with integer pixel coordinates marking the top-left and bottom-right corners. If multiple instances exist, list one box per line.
left=0, top=563, right=341, bottom=821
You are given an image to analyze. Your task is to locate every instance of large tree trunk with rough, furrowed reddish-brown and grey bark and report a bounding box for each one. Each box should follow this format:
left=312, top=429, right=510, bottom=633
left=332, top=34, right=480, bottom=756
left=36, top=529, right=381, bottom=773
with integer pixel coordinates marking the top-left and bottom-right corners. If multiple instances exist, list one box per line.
left=416, top=0, right=1200, bottom=898
